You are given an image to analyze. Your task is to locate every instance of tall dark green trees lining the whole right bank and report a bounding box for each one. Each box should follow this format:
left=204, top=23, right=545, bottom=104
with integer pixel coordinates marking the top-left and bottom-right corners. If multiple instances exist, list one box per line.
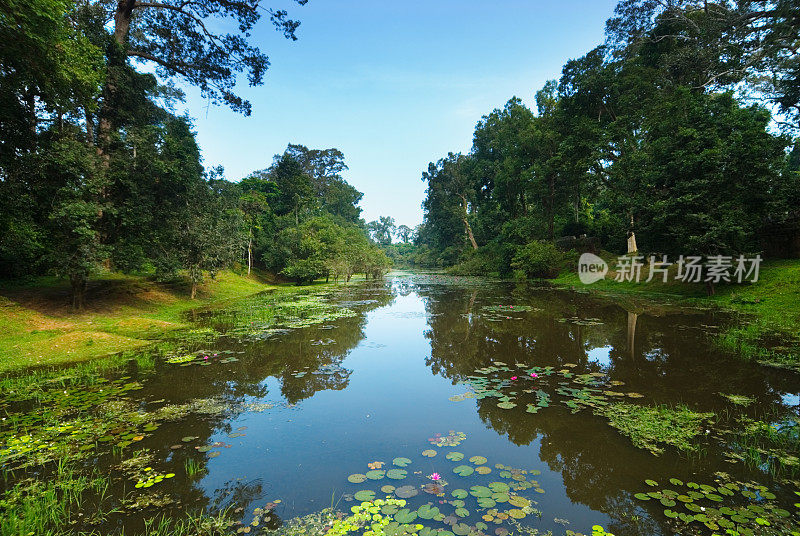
left=407, top=0, right=800, bottom=275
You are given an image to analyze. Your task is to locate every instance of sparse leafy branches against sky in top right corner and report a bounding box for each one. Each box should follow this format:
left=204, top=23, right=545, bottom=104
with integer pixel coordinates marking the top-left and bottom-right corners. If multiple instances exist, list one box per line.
left=607, top=0, right=800, bottom=128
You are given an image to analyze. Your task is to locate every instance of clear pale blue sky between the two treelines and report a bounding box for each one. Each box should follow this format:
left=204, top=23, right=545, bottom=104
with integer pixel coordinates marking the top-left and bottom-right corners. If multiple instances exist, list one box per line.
left=185, top=0, right=616, bottom=227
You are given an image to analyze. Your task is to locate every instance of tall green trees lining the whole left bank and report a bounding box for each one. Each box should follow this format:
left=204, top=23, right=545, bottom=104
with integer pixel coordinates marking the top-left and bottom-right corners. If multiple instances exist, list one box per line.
left=0, top=0, right=390, bottom=307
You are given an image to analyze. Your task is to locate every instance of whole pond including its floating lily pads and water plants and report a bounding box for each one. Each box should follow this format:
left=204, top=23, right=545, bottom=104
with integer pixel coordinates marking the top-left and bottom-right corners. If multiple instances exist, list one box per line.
left=0, top=273, right=800, bottom=536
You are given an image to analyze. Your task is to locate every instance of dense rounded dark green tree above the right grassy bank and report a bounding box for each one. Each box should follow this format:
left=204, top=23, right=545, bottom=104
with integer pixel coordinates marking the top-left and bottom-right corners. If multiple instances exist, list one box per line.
left=632, top=88, right=786, bottom=255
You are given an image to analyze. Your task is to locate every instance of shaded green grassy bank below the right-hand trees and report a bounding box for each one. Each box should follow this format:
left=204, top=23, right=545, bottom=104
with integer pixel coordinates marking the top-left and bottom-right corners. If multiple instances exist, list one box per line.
left=554, top=255, right=800, bottom=368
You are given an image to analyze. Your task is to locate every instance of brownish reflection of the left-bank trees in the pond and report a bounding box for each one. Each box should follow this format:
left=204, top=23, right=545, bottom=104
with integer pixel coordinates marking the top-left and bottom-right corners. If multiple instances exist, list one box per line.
left=120, top=282, right=395, bottom=524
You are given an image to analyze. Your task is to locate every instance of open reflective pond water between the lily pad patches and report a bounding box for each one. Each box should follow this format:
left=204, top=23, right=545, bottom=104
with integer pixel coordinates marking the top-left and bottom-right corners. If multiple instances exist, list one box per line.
left=1, top=274, right=800, bottom=536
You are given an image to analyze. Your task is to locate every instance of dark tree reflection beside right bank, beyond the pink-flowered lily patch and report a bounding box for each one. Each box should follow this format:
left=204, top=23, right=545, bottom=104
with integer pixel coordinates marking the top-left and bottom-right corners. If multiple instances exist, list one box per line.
left=423, top=285, right=797, bottom=413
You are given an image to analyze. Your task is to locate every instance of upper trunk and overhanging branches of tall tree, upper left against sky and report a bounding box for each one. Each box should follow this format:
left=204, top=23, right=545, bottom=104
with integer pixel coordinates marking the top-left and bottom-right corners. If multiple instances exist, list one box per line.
left=93, top=0, right=308, bottom=154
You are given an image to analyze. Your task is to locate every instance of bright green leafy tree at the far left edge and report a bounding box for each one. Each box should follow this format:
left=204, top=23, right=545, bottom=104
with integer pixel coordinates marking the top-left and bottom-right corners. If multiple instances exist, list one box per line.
left=0, top=0, right=103, bottom=280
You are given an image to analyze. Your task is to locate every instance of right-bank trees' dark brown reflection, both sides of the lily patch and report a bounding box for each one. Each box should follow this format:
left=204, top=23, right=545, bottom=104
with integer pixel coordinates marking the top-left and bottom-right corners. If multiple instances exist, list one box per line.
left=420, top=285, right=797, bottom=534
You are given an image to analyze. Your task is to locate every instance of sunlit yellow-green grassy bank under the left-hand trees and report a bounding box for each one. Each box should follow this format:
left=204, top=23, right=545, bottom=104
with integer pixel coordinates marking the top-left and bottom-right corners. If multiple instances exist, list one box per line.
left=0, top=272, right=276, bottom=372
